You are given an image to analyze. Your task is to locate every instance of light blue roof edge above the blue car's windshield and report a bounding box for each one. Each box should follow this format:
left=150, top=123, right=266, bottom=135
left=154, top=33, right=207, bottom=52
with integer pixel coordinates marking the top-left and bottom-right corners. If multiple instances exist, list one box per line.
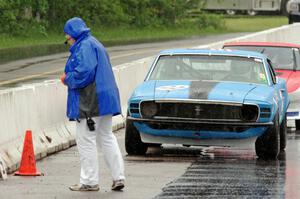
left=159, top=48, right=267, bottom=59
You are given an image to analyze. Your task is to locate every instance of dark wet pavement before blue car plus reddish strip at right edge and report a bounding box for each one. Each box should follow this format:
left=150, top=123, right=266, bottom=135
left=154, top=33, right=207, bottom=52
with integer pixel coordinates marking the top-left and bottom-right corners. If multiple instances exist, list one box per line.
left=155, top=132, right=300, bottom=199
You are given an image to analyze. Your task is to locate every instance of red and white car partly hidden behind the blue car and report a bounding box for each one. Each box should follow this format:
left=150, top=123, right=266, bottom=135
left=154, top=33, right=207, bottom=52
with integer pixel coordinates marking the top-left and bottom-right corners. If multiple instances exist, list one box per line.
left=224, top=42, right=300, bottom=130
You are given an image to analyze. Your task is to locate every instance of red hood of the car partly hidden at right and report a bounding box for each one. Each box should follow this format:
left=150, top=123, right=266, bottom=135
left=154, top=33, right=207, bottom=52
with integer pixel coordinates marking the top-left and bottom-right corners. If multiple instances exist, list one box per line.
left=276, top=70, right=300, bottom=93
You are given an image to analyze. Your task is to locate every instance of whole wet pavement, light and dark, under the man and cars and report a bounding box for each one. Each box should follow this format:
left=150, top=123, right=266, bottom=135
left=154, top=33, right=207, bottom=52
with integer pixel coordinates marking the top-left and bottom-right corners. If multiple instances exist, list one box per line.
left=0, top=129, right=300, bottom=199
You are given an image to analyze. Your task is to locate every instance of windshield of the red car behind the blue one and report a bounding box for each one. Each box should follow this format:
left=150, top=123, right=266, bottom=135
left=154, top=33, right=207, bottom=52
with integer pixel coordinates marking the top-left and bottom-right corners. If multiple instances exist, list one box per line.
left=225, top=46, right=300, bottom=70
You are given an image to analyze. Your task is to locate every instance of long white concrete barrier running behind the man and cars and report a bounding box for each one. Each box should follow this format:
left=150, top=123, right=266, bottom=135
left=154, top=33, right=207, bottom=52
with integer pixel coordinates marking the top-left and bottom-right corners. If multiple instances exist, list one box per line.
left=0, top=24, right=300, bottom=176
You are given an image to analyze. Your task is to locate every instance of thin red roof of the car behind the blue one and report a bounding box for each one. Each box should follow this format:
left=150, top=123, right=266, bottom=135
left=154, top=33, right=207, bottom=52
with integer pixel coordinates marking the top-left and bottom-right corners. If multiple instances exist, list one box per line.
left=224, top=42, right=300, bottom=48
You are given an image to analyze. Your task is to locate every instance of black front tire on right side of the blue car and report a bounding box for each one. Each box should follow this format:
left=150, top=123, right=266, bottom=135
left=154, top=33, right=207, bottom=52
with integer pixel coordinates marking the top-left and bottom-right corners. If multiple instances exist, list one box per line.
left=255, top=114, right=280, bottom=159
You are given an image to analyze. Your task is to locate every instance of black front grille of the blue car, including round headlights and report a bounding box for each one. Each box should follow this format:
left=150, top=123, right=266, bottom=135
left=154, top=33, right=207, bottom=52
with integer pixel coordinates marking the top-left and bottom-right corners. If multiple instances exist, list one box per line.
left=140, top=101, right=258, bottom=122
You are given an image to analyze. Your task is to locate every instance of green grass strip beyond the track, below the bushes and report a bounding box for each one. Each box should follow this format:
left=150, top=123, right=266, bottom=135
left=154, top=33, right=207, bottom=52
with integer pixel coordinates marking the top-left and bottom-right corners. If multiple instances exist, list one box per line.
left=0, top=16, right=288, bottom=49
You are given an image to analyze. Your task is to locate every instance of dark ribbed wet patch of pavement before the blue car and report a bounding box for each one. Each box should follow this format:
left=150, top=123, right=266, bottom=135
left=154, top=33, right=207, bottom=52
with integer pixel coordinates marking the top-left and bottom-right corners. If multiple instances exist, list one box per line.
left=156, top=152, right=286, bottom=199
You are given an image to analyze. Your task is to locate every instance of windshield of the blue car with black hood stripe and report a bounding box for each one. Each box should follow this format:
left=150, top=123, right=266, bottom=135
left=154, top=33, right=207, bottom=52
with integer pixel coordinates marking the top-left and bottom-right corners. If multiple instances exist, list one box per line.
left=149, top=55, right=267, bottom=84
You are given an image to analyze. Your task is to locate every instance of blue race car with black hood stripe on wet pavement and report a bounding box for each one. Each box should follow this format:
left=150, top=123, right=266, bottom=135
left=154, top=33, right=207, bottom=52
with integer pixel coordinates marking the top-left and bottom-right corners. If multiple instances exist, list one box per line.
left=125, top=49, right=289, bottom=159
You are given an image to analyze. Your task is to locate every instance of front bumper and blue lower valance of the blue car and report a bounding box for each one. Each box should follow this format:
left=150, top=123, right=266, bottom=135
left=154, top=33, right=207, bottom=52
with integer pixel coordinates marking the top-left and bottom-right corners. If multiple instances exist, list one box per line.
left=127, top=117, right=273, bottom=140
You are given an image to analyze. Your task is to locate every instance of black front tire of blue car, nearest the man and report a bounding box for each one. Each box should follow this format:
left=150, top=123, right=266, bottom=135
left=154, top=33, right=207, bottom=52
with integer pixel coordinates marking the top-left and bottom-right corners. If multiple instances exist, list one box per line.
left=125, top=119, right=148, bottom=155
